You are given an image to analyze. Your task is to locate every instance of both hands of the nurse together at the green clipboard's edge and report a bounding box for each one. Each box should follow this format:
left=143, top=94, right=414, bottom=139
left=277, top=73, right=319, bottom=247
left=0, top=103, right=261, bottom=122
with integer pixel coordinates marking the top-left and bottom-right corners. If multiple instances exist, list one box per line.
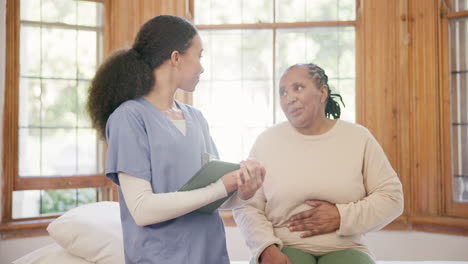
left=222, top=160, right=266, bottom=200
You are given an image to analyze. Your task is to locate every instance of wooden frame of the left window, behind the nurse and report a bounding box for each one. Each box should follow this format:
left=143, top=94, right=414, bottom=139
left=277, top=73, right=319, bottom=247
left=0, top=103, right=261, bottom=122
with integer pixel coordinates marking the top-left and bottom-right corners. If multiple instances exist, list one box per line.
left=0, top=0, right=116, bottom=238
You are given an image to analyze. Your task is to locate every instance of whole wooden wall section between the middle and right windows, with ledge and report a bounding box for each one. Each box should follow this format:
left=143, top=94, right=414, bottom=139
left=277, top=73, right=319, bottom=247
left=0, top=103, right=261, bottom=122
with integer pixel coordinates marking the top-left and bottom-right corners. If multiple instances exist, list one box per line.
left=357, top=0, right=468, bottom=231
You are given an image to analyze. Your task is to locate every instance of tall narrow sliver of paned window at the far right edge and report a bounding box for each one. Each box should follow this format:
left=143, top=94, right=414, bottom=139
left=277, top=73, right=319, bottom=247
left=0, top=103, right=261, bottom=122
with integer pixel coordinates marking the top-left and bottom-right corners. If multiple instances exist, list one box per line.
left=449, top=18, right=468, bottom=202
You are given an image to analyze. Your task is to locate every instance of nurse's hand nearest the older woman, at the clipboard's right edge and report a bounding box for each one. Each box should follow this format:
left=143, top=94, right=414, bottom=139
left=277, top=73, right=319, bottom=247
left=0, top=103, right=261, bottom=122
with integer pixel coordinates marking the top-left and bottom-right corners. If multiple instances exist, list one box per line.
left=237, top=160, right=266, bottom=200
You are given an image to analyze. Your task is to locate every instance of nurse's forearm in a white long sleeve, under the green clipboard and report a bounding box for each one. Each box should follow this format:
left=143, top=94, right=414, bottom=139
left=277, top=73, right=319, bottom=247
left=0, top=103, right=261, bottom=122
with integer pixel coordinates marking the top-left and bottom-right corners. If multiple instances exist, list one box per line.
left=119, top=173, right=227, bottom=226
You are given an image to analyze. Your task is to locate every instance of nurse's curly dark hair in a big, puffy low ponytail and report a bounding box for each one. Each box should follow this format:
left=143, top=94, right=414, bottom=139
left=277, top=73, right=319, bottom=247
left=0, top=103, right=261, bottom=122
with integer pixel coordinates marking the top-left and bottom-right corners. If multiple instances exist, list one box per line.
left=86, top=15, right=198, bottom=139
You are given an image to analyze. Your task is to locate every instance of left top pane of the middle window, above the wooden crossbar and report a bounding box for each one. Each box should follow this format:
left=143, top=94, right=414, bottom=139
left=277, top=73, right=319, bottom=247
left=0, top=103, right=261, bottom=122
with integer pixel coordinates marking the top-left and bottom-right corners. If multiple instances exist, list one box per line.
left=195, top=0, right=273, bottom=25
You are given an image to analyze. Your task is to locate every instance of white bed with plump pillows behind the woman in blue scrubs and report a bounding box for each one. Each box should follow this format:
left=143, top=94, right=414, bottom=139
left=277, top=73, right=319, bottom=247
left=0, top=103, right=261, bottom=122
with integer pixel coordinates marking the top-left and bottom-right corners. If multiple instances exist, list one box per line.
left=13, top=202, right=468, bottom=264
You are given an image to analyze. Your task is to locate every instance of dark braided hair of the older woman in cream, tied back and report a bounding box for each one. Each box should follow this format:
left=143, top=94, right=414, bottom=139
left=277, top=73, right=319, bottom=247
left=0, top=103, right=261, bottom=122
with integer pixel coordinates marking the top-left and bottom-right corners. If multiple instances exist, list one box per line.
left=286, top=63, right=346, bottom=119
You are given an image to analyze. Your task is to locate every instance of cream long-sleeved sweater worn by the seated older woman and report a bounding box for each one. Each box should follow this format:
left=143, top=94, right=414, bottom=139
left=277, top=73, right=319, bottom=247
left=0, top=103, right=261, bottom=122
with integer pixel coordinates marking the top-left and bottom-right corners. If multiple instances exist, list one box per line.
left=234, top=120, right=403, bottom=259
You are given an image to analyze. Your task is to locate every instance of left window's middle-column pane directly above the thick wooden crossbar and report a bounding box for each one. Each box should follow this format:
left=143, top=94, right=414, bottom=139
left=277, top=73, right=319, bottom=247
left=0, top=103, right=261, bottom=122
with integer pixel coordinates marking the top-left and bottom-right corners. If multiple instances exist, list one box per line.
left=41, top=128, right=77, bottom=176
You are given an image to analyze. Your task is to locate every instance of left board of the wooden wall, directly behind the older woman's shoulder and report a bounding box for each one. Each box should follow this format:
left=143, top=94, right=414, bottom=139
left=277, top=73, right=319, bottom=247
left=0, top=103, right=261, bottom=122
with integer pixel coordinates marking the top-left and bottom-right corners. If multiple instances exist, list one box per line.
left=359, top=1, right=399, bottom=172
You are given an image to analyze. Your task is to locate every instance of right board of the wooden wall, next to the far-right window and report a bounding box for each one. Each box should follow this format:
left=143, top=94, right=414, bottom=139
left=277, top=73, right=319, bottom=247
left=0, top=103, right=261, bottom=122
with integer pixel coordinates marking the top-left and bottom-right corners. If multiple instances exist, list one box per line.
left=407, top=0, right=442, bottom=216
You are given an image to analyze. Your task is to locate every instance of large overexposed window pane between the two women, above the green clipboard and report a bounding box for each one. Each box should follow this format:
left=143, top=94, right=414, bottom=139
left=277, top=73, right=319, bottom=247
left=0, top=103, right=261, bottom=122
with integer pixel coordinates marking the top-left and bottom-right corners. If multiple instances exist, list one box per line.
left=194, top=80, right=273, bottom=162
